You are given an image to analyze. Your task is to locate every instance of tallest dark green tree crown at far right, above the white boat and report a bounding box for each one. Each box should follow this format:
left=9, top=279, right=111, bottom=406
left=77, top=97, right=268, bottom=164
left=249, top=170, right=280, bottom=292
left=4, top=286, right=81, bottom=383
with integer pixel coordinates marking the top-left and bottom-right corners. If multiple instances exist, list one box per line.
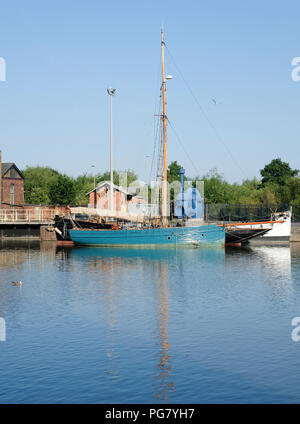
left=260, top=158, right=299, bottom=186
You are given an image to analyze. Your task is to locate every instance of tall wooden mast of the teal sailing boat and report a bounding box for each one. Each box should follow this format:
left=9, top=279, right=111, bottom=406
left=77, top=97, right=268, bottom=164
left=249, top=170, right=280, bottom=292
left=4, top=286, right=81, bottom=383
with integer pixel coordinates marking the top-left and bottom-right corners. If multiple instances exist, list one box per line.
left=161, top=30, right=167, bottom=227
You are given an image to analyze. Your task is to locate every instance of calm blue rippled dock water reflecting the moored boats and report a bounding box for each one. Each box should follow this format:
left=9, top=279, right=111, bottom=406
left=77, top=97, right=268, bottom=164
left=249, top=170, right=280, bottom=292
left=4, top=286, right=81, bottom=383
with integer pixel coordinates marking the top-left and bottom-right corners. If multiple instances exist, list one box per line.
left=0, top=243, right=300, bottom=403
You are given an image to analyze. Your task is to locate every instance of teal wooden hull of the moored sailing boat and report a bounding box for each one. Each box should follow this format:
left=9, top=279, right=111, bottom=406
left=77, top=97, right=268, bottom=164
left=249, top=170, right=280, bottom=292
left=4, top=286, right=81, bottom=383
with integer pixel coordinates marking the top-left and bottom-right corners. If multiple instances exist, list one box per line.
left=69, top=225, right=225, bottom=246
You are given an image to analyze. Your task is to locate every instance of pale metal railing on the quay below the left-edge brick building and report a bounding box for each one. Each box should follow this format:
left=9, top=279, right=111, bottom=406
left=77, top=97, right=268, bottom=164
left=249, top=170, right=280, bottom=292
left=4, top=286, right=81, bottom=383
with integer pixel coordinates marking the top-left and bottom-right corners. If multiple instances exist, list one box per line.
left=0, top=207, right=55, bottom=223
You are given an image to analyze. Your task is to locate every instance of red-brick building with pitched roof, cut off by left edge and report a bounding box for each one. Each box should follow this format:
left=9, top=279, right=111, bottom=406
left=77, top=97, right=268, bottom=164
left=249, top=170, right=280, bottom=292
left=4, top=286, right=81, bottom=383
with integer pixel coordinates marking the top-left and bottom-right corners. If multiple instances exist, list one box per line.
left=0, top=151, right=24, bottom=208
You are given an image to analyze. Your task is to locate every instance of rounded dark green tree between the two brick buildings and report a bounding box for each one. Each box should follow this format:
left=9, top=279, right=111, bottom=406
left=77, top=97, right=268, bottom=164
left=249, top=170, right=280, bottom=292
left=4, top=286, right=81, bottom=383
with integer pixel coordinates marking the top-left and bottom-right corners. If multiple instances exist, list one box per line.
left=49, top=175, right=76, bottom=205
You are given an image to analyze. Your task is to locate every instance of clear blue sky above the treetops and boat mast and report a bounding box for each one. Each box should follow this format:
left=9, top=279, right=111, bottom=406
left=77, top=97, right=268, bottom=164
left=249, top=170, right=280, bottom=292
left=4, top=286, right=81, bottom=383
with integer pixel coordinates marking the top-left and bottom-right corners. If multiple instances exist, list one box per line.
left=0, top=0, right=300, bottom=181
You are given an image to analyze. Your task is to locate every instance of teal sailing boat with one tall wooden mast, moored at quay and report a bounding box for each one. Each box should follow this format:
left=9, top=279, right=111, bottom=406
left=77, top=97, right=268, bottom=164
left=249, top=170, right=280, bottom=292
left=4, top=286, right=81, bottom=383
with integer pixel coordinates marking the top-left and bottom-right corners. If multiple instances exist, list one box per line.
left=69, top=31, right=225, bottom=246
